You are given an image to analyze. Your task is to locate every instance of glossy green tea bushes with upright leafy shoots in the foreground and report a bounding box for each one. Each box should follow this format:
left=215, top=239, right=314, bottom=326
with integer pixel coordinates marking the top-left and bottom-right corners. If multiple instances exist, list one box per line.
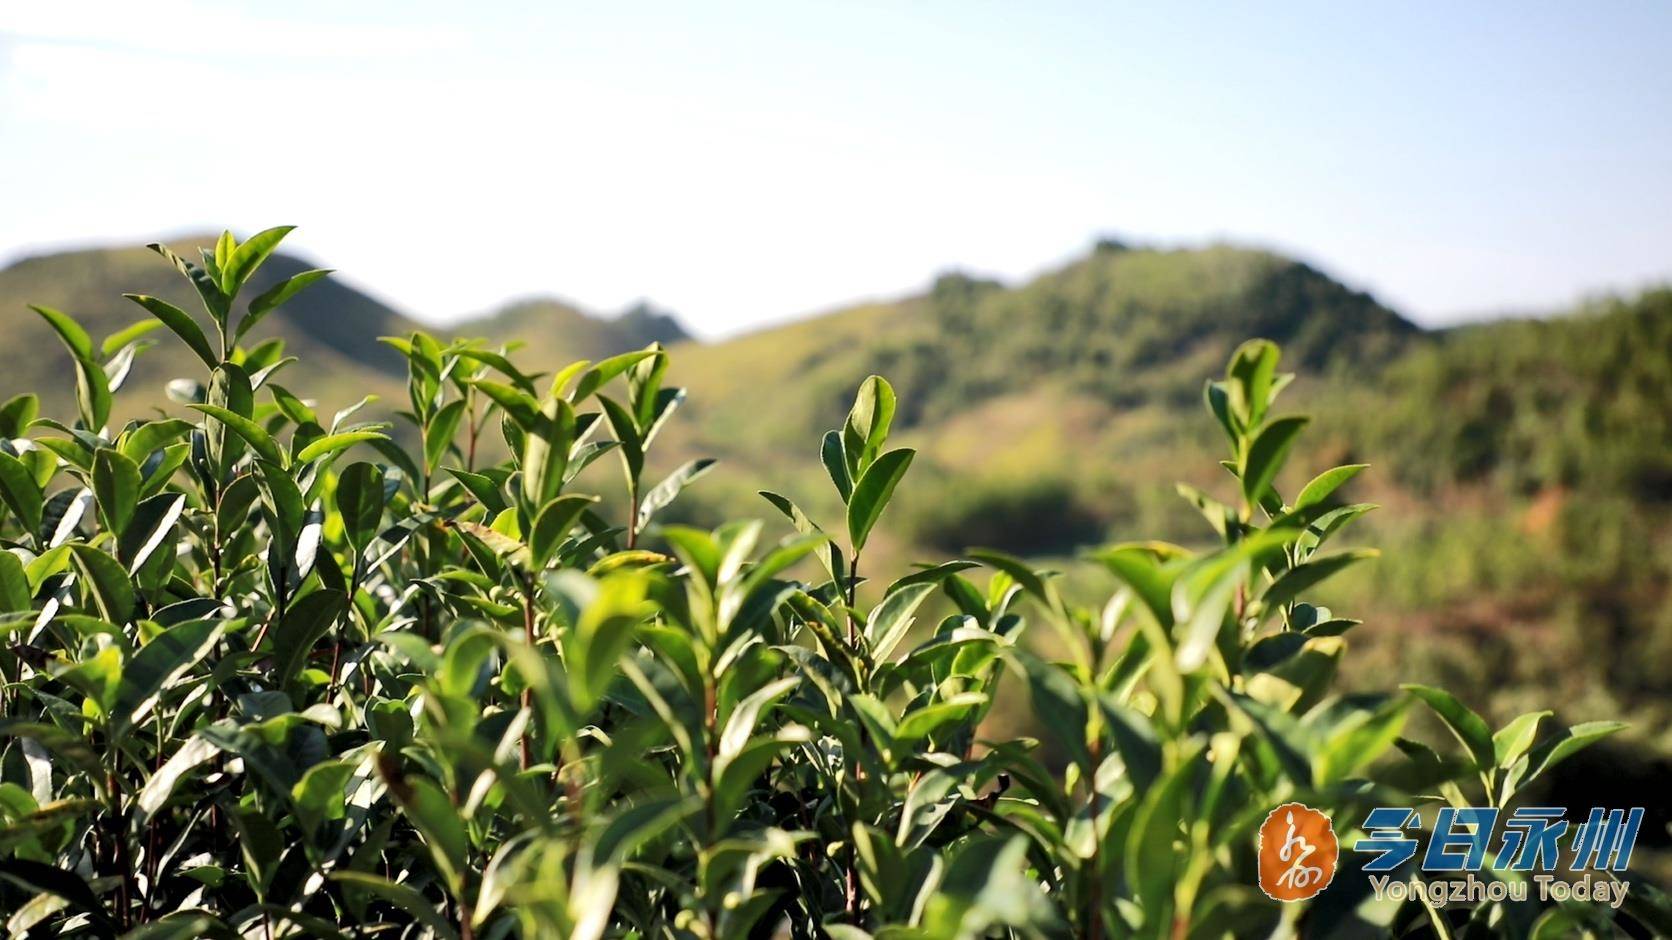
left=0, top=227, right=1665, bottom=940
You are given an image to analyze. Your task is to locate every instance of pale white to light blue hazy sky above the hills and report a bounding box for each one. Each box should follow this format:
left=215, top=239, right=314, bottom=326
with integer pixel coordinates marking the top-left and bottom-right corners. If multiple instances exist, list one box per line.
left=0, top=0, right=1672, bottom=335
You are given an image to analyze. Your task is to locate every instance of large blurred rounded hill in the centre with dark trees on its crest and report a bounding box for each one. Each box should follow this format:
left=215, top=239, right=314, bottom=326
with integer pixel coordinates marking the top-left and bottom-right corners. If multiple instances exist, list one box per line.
left=670, top=244, right=1425, bottom=554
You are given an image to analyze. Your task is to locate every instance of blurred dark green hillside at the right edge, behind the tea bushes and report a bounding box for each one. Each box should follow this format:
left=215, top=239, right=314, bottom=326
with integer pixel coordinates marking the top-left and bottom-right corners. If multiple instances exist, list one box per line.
left=1323, top=289, right=1672, bottom=739
